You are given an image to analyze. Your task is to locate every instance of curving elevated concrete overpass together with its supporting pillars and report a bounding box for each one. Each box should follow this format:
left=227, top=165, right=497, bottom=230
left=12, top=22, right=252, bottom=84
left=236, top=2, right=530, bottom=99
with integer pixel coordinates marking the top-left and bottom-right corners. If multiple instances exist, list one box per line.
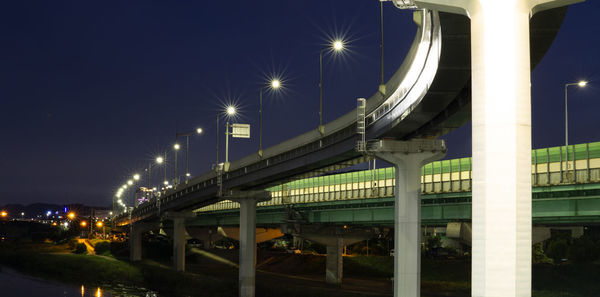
left=114, top=0, right=577, bottom=297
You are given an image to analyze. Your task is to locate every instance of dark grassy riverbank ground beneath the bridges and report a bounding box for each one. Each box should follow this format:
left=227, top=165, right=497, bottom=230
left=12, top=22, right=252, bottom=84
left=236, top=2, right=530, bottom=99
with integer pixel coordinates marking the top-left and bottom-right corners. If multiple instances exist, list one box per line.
left=0, top=243, right=600, bottom=297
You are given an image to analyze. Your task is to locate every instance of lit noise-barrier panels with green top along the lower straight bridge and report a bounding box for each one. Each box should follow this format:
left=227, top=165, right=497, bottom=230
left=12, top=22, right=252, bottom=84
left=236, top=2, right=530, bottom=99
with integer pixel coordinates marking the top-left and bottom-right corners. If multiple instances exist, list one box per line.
left=196, top=142, right=600, bottom=216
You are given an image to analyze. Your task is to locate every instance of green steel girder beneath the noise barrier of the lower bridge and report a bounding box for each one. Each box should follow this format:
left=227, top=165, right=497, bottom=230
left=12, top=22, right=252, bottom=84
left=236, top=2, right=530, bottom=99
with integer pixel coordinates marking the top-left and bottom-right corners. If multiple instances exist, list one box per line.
left=190, top=184, right=600, bottom=226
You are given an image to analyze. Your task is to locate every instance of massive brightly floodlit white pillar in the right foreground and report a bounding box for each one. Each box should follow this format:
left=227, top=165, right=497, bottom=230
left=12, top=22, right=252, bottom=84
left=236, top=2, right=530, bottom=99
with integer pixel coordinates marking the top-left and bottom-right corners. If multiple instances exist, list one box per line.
left=397, top=0, right=580, bottom=297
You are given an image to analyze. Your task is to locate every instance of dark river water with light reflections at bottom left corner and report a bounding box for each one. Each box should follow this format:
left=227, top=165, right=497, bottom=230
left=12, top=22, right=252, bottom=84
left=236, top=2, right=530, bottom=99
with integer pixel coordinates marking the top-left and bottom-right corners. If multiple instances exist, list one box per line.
left=0, top=267, right=159, bottom=297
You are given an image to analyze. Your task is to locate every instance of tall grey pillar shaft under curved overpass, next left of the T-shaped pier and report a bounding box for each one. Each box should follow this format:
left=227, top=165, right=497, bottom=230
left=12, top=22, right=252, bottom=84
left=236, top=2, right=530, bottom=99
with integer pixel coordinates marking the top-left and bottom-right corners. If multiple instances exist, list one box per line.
left=238, top=198, right=257, bottom=297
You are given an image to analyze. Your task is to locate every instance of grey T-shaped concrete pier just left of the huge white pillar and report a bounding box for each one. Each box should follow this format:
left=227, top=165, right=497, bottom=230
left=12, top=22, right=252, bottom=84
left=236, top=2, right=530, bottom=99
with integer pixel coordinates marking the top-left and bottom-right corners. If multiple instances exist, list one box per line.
left=367, top=139, right=446, bottom=297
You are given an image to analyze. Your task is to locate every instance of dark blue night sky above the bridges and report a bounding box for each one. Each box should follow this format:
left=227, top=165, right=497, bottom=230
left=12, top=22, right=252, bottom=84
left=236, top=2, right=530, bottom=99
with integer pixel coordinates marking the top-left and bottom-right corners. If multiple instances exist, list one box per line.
left=0, top=0, right=600, bottom=206
